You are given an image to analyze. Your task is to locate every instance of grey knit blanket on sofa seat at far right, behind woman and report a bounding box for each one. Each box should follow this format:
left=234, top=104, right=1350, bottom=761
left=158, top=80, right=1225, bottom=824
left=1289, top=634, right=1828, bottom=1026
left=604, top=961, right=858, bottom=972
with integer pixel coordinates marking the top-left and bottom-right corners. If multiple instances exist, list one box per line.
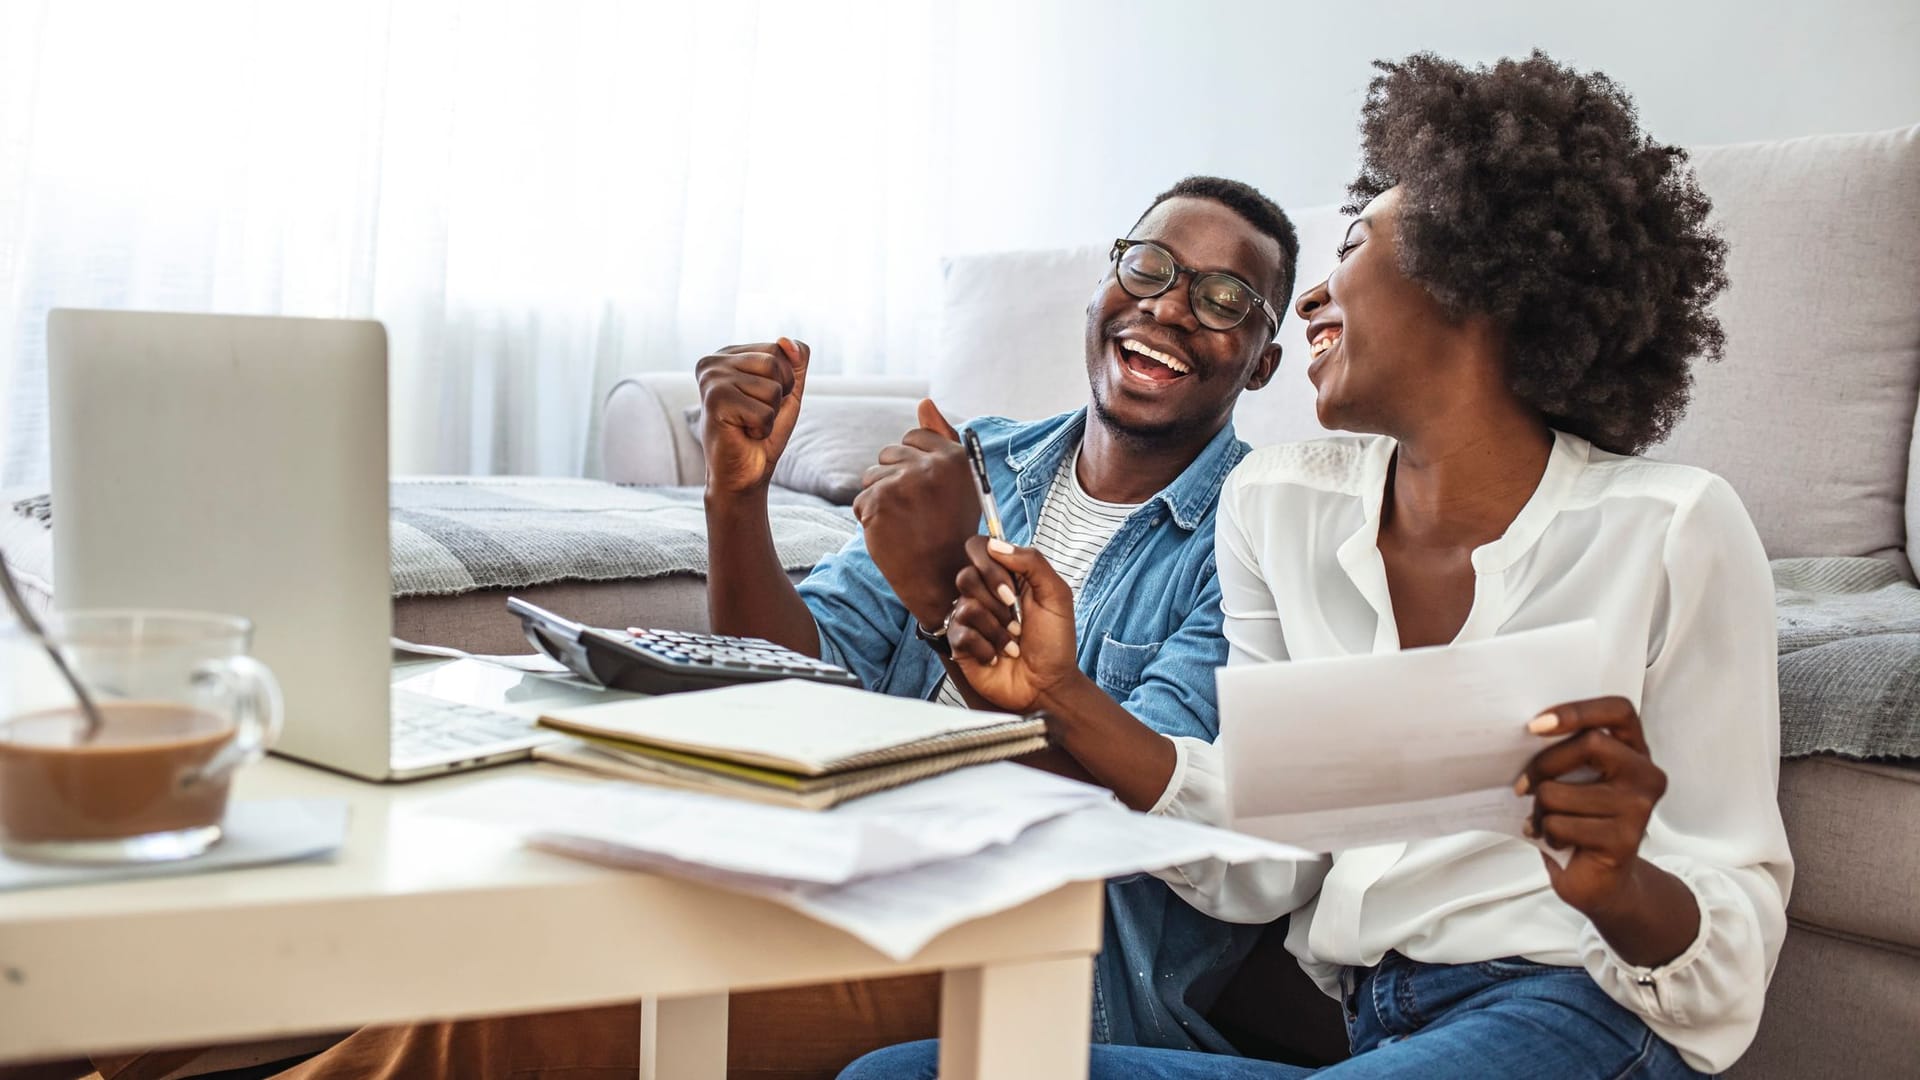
left=1774, top=559, right=1920, bottom=757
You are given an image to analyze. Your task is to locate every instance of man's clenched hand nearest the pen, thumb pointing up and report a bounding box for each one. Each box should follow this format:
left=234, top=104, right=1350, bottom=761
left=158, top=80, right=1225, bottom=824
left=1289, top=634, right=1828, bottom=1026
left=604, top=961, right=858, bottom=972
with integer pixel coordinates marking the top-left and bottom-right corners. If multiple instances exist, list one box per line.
left=852, top=400, right=979, bottom=626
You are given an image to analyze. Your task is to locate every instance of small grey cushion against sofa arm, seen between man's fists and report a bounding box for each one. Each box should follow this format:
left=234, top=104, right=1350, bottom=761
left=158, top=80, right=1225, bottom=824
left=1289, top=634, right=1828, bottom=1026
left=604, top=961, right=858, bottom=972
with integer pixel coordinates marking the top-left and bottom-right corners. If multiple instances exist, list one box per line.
left=685, top=396, right=920, bottom=505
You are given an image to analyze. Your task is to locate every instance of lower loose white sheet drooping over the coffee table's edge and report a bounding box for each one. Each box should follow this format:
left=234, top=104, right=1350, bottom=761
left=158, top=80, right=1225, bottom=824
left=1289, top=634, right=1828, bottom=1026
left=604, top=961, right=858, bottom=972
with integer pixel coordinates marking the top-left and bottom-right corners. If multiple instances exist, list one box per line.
left=536, top=803, right=1313, bottom=961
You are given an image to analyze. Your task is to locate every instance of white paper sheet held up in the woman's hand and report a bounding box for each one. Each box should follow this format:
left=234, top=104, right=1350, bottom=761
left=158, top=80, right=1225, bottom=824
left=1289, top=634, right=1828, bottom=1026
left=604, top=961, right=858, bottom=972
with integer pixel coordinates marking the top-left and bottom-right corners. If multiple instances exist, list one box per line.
left=1219, top=619, right=1603, bottom=851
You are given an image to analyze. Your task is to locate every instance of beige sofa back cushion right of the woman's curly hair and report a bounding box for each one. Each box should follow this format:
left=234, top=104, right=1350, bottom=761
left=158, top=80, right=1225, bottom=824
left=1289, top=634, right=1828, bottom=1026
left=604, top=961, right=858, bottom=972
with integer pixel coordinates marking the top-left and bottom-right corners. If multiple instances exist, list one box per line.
left=1651, top=127, right=1920, bottom=571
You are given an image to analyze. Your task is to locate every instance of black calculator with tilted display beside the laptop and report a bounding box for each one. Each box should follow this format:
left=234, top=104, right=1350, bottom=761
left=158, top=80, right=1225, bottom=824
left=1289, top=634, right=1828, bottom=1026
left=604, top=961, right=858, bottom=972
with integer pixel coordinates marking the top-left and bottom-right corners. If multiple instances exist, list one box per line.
left=507, top=596, right=860, bottom=694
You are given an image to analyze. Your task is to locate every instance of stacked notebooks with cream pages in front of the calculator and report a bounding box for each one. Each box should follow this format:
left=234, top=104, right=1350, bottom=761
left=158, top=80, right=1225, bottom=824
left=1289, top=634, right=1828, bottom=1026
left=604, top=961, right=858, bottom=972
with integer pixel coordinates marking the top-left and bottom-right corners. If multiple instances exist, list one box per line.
left=536, top=680, right=1046, bottom=809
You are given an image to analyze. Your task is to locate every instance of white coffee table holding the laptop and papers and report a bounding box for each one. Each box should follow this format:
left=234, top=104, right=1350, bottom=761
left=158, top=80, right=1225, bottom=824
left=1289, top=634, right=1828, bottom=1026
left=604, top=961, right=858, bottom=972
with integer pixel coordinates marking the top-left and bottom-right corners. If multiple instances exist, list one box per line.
left=0, top=759, right=1102, bottom=1080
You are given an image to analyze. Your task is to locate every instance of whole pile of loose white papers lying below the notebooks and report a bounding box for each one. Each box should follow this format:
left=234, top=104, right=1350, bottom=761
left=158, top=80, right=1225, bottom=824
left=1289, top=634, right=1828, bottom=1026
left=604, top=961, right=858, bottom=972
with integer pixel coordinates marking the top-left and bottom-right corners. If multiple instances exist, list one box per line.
left=422, top=763, right=1311, bottom=959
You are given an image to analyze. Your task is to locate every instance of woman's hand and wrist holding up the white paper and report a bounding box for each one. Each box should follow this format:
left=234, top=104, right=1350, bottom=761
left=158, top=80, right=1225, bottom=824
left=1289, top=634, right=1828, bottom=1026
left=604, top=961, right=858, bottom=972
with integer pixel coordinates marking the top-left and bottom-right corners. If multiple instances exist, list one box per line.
left=1513, top=698, right=1699, bottom=967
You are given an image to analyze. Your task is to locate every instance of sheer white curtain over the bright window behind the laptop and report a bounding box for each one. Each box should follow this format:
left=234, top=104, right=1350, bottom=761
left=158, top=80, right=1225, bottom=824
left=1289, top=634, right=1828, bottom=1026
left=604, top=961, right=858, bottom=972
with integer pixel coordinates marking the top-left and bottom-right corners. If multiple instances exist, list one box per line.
left=0, top=0, right=952, bottom=478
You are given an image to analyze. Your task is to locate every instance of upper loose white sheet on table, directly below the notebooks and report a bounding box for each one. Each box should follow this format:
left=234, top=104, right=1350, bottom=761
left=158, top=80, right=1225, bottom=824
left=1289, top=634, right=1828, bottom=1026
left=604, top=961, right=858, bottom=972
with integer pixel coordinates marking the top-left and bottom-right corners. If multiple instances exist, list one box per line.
left=419, top=763, right=1114, bottom=884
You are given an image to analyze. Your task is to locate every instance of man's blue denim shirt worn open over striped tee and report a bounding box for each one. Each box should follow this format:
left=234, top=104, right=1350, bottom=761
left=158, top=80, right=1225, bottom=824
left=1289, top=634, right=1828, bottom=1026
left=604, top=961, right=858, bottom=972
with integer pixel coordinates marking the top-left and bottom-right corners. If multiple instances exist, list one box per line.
left=801, top=409, right=1260, bottom=1053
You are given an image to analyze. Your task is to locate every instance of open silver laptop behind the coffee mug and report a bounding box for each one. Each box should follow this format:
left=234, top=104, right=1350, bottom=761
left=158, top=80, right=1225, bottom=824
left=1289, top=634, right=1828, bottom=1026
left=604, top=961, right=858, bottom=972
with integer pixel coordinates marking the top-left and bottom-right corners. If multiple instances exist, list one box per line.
left=46, top=309, right=593, bottom=780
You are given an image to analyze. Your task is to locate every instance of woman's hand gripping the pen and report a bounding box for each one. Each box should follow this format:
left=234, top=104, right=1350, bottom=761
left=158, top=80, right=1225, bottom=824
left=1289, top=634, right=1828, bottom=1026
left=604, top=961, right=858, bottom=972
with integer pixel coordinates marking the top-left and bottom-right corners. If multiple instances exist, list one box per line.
left=947, top=536, right=1081, bottom=713
